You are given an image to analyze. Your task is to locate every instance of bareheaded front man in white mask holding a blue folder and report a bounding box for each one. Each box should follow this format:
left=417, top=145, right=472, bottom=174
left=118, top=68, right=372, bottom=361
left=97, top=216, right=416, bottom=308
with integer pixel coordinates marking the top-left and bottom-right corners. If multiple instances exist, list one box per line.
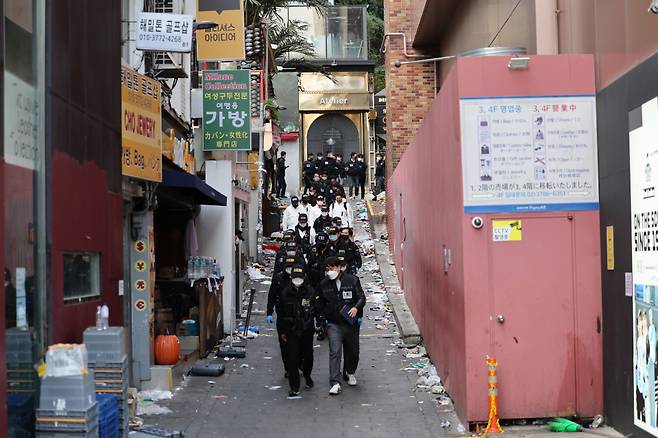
left=318, top=257, right=366, bottom=395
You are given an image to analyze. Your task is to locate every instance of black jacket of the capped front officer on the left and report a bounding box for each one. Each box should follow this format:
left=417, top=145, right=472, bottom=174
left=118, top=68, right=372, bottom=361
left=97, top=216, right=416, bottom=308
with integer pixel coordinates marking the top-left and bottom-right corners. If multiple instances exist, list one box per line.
left=276, top=282, right=318, bottom=335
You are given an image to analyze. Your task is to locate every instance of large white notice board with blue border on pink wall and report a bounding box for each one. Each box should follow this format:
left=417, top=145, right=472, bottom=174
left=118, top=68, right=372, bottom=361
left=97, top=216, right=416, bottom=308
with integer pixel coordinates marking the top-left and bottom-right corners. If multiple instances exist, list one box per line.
left=461, top=96, right=598, bottom=213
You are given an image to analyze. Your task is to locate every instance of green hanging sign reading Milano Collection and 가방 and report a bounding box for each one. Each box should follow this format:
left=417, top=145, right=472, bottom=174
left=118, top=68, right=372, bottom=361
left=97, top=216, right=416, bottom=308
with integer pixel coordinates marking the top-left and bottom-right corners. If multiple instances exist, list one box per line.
left=202, top=70, right=251, bottom=151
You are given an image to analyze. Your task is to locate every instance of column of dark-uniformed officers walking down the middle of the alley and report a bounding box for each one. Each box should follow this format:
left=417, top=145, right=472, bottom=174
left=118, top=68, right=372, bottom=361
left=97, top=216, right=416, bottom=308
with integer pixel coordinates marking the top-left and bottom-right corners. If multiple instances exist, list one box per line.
left=266, top=192, right=366, bottom=398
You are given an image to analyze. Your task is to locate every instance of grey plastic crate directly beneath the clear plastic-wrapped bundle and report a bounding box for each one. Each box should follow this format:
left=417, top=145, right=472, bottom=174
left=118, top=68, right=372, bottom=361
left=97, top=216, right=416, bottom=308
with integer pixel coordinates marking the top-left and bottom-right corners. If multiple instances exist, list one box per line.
left=39, top=374, right=96, bottom=411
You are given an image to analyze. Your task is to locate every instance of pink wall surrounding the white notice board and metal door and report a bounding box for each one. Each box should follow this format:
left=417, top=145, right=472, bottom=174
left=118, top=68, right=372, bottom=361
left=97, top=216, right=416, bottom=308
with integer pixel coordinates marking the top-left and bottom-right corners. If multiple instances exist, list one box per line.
left=387, top=55, right=602, bottom=421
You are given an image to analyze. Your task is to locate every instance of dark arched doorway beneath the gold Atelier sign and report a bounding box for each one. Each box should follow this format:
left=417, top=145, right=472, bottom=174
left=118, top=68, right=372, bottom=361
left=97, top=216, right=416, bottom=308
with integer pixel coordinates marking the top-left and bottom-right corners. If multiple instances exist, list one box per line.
left=307, top=114, right=361, bottom=158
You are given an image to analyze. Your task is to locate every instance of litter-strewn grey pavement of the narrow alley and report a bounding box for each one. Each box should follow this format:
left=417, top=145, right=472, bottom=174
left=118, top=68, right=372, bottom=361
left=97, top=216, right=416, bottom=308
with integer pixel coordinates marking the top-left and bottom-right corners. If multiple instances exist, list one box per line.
left=144, top=204, right=454, bottom=438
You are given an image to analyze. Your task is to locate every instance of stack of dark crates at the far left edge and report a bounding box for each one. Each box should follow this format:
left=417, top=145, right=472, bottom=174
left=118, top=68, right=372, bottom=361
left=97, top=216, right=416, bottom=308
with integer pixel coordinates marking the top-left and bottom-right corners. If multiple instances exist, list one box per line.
left=5, top=327, right=39, bottom=436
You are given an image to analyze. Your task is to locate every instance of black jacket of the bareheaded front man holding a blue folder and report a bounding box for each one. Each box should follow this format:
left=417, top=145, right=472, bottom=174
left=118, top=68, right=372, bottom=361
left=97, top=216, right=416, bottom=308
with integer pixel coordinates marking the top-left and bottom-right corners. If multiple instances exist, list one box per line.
left=318, top=272, right=366, bottom=324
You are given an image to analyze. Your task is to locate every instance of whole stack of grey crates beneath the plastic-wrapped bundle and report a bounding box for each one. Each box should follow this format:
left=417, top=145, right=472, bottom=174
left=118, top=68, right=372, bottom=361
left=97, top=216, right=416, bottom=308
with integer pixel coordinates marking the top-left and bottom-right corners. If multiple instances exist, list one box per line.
left=36, top=373, right=98, bottom=438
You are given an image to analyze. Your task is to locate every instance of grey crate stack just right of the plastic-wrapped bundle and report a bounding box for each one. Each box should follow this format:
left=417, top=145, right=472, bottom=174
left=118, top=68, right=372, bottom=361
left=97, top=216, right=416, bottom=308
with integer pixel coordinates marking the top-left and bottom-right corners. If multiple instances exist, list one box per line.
left=83, top=327, right=129, bottom=437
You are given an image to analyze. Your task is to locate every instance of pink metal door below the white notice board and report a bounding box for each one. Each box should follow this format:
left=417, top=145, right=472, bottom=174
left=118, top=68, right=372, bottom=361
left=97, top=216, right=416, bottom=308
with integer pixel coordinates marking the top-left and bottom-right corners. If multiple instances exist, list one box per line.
left=483, top=215, right=576, bottom=418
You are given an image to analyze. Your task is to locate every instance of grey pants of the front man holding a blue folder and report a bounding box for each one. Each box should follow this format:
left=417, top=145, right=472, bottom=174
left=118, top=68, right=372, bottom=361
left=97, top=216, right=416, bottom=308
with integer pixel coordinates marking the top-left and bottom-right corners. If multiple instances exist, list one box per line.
left=327, top=322, right=359, bottom=385
